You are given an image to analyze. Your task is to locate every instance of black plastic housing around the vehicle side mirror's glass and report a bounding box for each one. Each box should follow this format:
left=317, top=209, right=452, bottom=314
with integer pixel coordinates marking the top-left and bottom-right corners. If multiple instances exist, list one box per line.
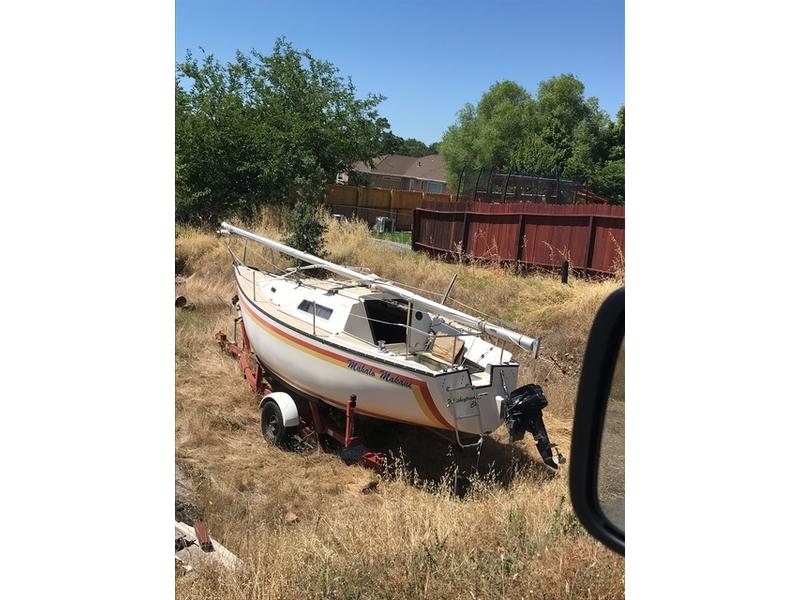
left=569, top=288, right=625, bottom=556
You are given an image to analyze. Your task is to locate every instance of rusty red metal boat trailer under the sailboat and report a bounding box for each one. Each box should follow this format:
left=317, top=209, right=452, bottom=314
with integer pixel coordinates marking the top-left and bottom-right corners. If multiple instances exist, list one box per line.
left=214, top=312, right=386, bottom=472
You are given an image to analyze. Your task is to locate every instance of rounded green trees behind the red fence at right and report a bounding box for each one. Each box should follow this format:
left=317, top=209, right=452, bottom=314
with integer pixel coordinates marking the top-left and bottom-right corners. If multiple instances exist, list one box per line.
left=439, top=74, right=625, bottom=201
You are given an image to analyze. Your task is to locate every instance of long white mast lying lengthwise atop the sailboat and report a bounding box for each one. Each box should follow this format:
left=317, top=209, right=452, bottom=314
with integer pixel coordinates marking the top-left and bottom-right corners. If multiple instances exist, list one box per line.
left=219, top=222, right=539, bottom=357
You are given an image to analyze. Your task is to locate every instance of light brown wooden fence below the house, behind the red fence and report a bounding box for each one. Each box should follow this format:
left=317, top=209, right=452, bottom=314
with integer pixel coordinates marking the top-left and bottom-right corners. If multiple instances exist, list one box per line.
left=325, top=185, right=455, bottom=231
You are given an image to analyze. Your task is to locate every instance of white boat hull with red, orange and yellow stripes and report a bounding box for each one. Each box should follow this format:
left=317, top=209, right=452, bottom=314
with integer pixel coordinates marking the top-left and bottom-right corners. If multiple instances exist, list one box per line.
left=234, top=287, right=517, bottom=434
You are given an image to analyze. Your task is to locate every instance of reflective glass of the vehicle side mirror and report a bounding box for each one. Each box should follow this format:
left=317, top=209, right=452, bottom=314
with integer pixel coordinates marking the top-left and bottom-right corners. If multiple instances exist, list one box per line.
left=597, top=340, right=625, bottom=534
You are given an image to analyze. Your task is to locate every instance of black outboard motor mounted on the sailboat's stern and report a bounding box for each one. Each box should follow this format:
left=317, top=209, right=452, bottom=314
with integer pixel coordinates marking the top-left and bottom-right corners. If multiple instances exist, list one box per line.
left=506, top=383, right=567, bottom=469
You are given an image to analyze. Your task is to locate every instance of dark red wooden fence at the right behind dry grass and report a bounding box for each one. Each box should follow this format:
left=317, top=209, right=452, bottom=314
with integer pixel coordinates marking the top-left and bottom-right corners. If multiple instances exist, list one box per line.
left=411, top=201, right=625, bottom=274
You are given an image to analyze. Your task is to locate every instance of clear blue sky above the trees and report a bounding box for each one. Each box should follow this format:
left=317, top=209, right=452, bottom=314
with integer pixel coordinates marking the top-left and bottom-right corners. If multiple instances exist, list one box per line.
left=175, top=0, right=625, bottom=144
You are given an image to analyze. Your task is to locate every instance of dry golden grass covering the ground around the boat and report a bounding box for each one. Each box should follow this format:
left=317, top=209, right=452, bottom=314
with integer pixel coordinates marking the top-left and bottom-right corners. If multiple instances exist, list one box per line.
left=175, top=218, right=624, bottom=599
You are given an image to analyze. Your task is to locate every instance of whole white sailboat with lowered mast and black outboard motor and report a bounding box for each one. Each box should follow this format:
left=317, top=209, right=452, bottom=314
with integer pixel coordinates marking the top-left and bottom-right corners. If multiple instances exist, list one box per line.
left=219, top=223, right=564, bottom=469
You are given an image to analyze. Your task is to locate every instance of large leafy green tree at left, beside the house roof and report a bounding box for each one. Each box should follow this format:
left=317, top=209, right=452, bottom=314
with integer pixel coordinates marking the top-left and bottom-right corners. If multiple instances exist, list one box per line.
left=175, top=38, right=396, bottom=221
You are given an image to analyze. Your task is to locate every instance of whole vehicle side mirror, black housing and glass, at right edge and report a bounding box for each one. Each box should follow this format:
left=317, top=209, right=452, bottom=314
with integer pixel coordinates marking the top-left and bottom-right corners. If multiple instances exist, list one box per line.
left=569, top=288, right=625, bottom=556
